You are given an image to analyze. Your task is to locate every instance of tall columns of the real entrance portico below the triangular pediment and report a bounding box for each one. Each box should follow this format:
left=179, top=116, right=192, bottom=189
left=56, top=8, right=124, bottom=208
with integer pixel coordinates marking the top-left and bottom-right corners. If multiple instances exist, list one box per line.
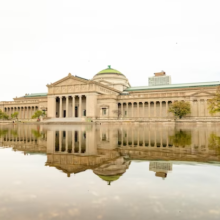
left=55, top=95, right=86, bottom=118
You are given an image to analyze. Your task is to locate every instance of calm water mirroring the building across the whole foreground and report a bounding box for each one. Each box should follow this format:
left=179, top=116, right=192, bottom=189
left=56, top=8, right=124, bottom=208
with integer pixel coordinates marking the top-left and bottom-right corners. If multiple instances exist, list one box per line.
left=0, top=125, right=220, bottom=220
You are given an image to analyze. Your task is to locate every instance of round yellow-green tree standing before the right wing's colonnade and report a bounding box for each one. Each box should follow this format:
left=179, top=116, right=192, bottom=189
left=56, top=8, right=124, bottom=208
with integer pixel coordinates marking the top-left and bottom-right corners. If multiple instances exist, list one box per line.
left=168, top=101, right=191, bottom=119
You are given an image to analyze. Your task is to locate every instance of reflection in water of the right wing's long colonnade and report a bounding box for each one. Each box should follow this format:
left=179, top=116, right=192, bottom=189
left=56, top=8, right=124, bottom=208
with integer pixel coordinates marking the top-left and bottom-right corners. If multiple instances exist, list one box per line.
left=118, top=127, right=211, bottom=151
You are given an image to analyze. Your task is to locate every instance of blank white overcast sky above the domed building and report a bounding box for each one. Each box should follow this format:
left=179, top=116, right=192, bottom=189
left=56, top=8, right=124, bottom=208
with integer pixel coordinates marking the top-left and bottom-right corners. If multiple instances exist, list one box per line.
left=0, top=0, right=220, bottom=101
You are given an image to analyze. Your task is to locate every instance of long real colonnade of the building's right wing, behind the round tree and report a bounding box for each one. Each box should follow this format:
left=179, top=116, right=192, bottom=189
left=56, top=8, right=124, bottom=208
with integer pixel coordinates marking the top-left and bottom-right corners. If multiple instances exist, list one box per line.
left=118, top=99, right=214, bottom=118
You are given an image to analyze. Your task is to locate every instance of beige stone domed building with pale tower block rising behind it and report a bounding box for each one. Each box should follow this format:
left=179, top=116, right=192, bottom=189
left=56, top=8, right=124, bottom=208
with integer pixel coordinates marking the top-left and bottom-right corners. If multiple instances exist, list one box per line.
left=0, top=66, right=220, bottom=121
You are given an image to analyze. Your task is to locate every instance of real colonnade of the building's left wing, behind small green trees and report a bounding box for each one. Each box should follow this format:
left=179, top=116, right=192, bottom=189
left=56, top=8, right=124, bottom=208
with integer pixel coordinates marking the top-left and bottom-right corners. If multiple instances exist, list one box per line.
left=4, top=106, right=39, bottom=119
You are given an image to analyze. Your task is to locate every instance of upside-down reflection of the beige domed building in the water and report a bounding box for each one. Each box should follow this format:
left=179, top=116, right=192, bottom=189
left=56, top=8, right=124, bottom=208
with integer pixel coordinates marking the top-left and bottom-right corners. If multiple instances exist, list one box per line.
left=0, top=125, right=220, bottom=185
